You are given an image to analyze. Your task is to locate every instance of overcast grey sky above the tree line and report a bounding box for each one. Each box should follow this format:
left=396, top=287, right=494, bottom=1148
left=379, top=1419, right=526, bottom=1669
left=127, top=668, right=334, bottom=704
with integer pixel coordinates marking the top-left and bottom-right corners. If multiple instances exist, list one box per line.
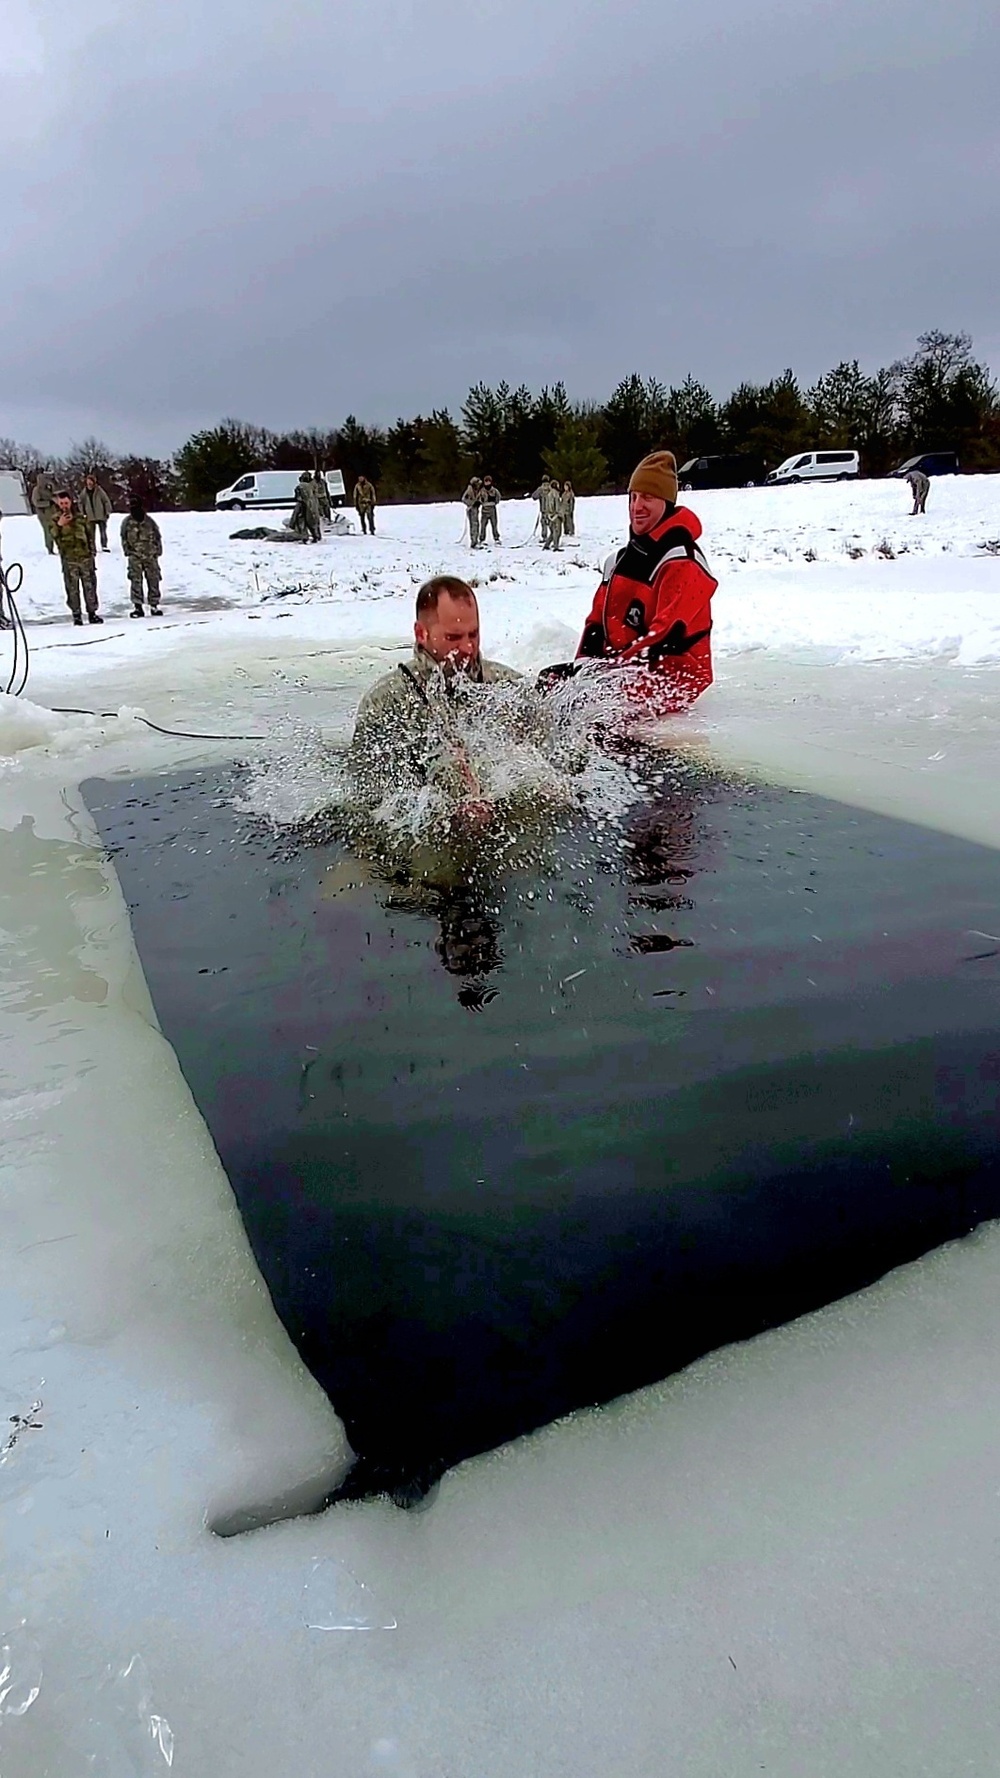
left=0, top=0, right=1000, bottom=452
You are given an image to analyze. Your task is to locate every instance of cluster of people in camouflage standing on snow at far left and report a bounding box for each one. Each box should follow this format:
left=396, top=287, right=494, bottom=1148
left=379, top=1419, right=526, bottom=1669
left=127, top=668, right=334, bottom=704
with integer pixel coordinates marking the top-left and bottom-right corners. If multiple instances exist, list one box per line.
left=32, top=469, right=164, bottom=624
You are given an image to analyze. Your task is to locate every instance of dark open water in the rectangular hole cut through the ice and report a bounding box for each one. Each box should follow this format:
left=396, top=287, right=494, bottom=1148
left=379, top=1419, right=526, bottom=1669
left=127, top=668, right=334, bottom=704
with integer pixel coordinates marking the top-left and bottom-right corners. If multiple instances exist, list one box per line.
left=85, top=772, right=1000, bottom=1501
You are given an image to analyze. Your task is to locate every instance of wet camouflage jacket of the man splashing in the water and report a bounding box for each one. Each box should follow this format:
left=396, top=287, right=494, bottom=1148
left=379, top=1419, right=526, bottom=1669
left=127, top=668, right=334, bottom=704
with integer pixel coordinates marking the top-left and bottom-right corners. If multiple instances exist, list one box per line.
left=347, top=649, right=520, bottom=809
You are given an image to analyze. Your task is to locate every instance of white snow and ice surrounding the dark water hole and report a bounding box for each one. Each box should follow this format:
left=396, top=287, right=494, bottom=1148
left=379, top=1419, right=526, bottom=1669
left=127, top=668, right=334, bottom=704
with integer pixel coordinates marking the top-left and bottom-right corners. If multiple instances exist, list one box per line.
left=0, top=477, right=1000, bottom=1778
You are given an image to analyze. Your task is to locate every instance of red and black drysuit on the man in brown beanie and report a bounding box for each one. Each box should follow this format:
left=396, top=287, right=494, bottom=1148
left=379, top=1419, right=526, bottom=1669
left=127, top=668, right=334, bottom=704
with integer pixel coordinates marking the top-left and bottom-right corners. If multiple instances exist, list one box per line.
left=577, top=507, right=719, bottom=715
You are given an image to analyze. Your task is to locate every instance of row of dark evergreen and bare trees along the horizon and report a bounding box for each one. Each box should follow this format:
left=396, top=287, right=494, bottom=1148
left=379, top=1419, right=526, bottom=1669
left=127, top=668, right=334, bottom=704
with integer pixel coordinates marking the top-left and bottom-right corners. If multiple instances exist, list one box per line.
left=0, top=331, right=1000, bottom=510
